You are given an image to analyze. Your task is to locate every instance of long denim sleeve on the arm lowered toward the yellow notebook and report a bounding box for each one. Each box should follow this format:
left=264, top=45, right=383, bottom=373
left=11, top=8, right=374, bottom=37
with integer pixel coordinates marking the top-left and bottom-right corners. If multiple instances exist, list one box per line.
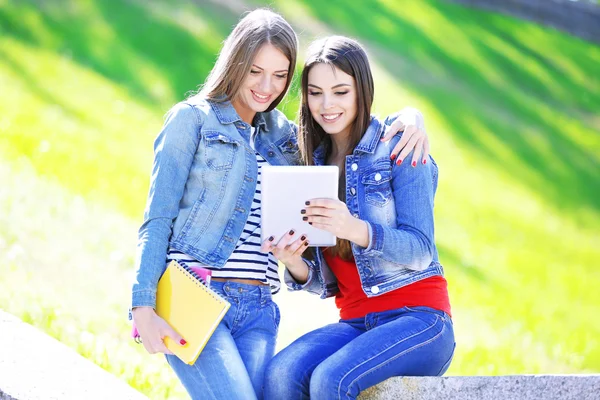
left=132, top=103, right=201, bottom=307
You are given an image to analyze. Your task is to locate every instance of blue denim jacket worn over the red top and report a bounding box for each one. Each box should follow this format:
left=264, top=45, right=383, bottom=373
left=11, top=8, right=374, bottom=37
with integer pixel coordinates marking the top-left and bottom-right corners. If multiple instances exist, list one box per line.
left=285, top=117, right=443, bottom=298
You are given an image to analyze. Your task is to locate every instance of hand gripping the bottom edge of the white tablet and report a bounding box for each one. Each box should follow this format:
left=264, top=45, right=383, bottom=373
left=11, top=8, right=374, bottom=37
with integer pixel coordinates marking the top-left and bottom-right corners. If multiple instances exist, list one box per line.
left=260, top=230, right=309, bottom=283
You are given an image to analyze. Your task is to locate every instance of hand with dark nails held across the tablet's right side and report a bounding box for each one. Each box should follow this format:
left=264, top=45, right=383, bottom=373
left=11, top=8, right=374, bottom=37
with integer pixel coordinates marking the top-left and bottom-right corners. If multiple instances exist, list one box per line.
left=302, top=199, right=369, bottom=247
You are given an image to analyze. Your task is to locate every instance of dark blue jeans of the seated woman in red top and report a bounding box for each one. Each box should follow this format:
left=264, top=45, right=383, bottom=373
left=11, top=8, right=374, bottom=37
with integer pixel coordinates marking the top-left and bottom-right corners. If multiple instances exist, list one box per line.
left=265, top=307, right=455, bottom=400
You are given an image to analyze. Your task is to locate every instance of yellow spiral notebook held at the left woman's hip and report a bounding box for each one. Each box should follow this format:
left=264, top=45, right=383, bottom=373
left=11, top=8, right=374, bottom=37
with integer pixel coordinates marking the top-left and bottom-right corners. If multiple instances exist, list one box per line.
left=156, top=261, right=230, bottom=365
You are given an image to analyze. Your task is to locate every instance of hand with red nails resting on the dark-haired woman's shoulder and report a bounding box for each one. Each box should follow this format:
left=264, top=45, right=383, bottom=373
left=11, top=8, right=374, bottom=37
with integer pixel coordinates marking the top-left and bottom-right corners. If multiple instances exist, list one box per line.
left=381, top=107, right=429, bottom=167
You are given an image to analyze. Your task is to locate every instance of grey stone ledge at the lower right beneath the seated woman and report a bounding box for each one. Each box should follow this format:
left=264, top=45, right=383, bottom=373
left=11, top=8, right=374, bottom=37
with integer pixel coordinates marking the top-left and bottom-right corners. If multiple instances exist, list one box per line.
left=358, top=375, right=600, bottom=400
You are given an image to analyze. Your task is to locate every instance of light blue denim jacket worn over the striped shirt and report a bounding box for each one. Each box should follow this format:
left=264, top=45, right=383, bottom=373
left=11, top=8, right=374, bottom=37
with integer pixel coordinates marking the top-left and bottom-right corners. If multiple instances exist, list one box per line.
left=132, top=96, right=300, bottom=307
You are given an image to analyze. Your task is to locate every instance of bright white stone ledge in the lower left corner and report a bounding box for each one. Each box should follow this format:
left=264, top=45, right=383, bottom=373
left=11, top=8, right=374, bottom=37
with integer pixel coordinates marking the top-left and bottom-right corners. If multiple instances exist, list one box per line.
left=0, top=310, right=148, bottom=400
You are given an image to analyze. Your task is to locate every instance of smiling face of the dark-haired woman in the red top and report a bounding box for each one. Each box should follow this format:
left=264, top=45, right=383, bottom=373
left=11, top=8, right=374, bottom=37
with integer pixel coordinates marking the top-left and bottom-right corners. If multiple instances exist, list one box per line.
left=307, top=63, right=358, bottom=140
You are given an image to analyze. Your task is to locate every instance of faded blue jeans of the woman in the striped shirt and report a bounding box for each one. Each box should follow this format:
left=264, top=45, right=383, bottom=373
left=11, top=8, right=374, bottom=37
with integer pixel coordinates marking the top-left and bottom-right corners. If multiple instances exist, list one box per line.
left=166, top=281, right=279, bottom=400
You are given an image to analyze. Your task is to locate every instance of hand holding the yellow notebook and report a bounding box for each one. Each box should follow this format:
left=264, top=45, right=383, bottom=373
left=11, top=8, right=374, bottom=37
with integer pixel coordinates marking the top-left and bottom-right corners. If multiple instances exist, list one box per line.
left=131, top=307, right=186, bottom=354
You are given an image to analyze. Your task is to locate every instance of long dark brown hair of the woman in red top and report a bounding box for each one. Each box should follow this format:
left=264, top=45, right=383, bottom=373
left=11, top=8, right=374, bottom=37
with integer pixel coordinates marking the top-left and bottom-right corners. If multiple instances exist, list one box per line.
left=298, top=36, right=375, bottom=260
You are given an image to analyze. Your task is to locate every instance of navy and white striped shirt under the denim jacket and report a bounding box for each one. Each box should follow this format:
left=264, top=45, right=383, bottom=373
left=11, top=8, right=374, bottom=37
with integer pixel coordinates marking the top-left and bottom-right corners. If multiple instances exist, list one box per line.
left=167, top=127, right=281, bottom=294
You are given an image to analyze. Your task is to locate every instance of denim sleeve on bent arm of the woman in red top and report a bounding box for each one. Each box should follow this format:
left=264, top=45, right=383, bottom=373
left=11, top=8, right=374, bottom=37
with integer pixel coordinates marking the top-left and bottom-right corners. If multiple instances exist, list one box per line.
left=353, top=148, right=434, bottom=271
